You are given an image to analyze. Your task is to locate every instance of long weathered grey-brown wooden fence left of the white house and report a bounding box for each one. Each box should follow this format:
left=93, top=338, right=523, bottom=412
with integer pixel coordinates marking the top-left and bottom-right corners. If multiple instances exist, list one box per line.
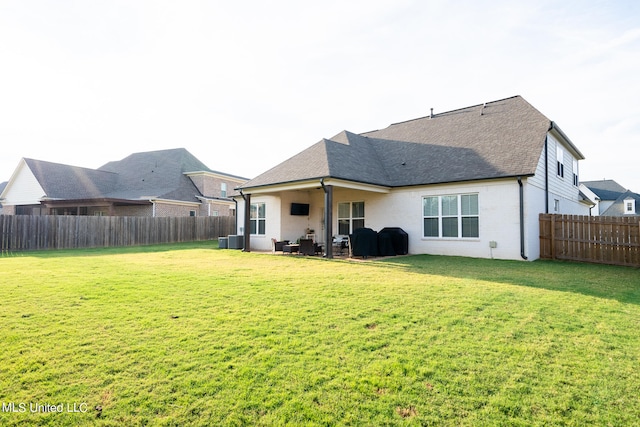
left=0, top=215, right=235, bottom=251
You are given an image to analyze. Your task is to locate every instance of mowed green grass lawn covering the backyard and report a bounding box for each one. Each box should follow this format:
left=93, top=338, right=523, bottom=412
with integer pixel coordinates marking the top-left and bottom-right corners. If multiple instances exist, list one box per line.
left=0, top=242, right=640, bottom=426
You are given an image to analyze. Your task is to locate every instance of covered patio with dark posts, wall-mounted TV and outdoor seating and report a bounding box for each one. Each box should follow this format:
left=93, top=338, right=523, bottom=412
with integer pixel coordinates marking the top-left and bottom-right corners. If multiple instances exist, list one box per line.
left=237, top=178, right=390, bottom=258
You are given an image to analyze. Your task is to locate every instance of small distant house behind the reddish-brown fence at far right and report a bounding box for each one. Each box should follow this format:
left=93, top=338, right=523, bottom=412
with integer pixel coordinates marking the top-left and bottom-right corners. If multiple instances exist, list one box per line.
left=580, top=179, right=640, bottom=216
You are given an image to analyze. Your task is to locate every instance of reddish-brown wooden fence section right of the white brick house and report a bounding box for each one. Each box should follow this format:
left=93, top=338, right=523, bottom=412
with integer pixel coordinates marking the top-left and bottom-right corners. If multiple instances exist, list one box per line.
left=540, top=214, right=640, bottom=267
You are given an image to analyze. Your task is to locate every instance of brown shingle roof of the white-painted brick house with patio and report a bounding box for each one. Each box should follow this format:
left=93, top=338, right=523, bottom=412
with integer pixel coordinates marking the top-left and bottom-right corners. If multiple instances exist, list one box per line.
left=241, top=96, right=584, bottom=189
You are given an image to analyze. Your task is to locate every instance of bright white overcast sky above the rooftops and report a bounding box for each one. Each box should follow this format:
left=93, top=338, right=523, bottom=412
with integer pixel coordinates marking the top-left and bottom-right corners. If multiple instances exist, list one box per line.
left=0, top=0, right=640, bottom=192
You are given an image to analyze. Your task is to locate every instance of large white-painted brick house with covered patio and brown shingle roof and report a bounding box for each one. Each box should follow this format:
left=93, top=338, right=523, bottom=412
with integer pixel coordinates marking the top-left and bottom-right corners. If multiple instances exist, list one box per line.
left=237, top=96, right=592, bottom=260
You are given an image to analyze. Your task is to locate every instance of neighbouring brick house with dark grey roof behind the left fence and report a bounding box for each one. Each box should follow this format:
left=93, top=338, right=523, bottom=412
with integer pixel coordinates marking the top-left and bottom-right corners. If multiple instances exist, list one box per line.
left=0, top=148, right=246, bottom=216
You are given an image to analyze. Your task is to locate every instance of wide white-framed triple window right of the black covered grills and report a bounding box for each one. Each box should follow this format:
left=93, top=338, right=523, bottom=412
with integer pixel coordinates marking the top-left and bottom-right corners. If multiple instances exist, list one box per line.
left=422, top=193, right=480, bottom=239
